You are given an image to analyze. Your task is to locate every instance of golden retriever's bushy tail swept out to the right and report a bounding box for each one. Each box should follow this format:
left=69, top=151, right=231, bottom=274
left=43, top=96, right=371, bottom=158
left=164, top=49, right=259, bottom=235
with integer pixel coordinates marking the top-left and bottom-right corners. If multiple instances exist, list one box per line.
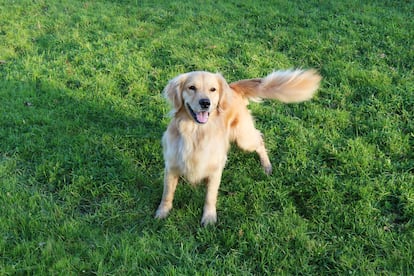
left=230, top=70, right=322, bottom=103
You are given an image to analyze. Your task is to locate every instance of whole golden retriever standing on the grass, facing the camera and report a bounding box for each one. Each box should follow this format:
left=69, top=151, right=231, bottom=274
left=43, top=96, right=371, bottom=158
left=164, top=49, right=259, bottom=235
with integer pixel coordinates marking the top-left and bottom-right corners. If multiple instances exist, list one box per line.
left=155, top=69, right=321, bottom=226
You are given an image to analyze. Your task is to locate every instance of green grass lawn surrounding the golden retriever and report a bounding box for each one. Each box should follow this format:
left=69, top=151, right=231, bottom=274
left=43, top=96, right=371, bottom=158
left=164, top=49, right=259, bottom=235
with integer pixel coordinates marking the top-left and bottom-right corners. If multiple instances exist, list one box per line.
left=0, top=0, right=414, bottom=275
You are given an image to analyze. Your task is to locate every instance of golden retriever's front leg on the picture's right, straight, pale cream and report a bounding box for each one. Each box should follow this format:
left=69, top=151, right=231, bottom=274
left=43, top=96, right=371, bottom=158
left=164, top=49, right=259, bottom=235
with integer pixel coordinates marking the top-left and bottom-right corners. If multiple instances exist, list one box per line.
left=201, top=170, right=222, bottom=226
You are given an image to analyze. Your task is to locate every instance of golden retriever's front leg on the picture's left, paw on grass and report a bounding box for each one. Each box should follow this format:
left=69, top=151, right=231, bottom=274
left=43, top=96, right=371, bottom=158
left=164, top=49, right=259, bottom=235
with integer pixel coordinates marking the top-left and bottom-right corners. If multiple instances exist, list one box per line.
left=155, top=169, right=178, bottom=219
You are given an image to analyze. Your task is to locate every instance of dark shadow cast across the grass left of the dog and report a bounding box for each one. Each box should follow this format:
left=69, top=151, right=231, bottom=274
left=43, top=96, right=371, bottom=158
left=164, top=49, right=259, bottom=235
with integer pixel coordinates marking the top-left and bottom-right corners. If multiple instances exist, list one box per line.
left=0, top=81, right=165, bottom=229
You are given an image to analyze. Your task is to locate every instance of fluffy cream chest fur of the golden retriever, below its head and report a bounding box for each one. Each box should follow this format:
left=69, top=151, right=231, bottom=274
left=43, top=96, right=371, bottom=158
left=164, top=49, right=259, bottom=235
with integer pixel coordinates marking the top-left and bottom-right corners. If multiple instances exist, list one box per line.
left=163, top=117, right=229, bottom=184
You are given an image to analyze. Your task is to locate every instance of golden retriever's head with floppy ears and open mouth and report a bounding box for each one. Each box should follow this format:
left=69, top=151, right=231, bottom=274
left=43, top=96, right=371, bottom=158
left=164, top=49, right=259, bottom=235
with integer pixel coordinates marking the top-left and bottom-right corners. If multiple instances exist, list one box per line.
left=164, top=71, right=231, bottom=124
